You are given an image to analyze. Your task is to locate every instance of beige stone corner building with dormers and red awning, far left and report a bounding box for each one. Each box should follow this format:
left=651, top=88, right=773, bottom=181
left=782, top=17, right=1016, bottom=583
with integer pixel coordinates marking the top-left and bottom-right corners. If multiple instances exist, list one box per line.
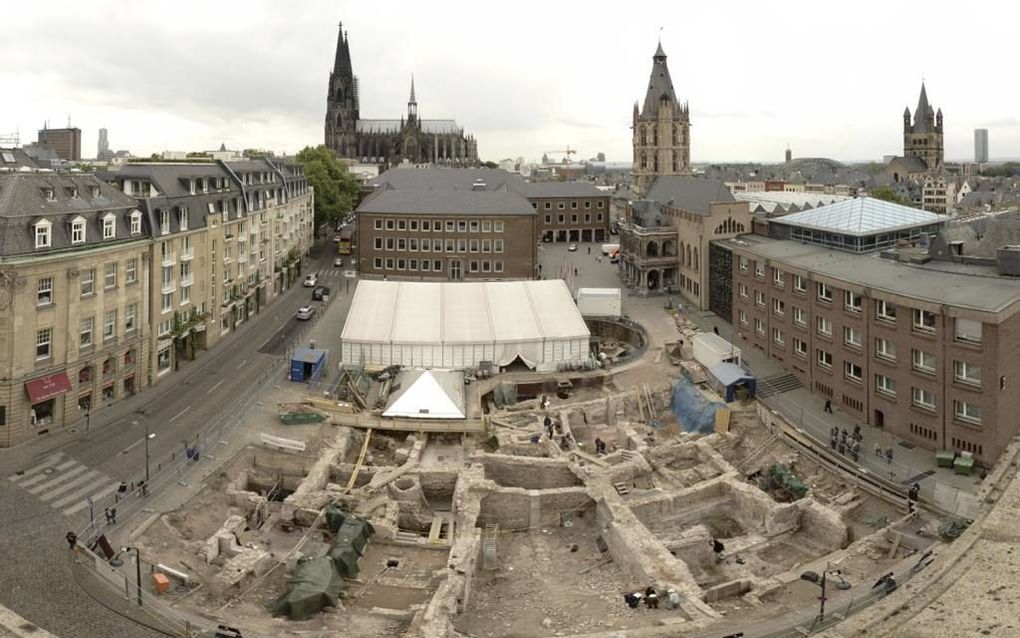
left=0, top=171, right=150, bottom=447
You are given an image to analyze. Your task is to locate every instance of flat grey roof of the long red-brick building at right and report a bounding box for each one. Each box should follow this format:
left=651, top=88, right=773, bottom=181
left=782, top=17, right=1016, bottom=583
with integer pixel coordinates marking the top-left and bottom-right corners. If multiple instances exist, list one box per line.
left=720, top=235, right=1020, bottom=312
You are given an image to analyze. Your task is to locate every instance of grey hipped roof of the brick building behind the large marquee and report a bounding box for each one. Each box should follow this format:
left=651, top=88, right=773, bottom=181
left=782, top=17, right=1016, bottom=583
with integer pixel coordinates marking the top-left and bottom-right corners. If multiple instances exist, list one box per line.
left=358, top=190, right=538, bottom=215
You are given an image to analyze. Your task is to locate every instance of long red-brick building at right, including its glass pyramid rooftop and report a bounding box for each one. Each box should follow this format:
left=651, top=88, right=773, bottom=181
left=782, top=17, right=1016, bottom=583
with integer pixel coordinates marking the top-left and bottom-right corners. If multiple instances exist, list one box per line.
left=713, top=199, right=1020, bottom=464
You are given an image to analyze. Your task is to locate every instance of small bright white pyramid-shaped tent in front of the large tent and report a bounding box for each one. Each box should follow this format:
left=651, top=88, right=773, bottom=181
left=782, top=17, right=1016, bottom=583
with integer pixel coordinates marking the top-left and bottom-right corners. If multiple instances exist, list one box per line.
left=383, top=370, right=464, bottom=419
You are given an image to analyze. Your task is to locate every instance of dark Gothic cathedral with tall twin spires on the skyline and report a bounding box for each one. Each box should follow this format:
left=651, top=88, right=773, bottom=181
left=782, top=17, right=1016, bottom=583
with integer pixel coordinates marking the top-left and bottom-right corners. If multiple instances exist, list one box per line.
left=325, top=24, right=478, bottom=167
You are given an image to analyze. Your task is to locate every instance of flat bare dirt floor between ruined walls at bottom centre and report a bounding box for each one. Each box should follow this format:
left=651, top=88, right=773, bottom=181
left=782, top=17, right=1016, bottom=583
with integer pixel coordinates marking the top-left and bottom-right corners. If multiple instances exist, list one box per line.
left=454, top=517, right=677, bottom=638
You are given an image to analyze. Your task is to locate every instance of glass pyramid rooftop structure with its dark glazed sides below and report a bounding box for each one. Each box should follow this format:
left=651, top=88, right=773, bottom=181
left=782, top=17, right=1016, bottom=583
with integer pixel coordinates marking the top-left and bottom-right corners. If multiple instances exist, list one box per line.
left=768, top=197, right=946, bottom=252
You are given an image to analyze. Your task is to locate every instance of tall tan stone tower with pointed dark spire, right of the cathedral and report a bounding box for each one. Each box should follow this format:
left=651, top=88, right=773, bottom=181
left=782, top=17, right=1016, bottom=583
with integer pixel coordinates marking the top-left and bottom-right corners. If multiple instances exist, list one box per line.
left=632, top=42, right=691, bottom=194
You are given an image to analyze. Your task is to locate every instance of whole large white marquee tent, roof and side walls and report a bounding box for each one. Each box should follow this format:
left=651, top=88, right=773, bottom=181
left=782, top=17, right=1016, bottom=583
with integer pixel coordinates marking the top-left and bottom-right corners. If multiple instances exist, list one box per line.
left=340, top=280, right=591, bottom=372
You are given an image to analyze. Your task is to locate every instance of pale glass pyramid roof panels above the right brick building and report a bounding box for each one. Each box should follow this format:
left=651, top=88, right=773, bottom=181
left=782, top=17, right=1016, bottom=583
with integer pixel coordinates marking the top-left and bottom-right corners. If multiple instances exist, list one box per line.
left=772, top=197, right=946, bottom=237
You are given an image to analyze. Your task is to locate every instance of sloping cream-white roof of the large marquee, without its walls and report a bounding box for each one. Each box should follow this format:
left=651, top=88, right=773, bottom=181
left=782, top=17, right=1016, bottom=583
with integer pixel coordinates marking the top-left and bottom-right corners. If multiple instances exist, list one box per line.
left=341, top=280, right=590, bottom=344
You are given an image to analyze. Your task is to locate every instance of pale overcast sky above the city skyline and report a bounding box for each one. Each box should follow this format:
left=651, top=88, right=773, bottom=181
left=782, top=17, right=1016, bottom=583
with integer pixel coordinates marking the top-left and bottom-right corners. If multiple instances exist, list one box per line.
left=0, top=0, right=1020, bottom=162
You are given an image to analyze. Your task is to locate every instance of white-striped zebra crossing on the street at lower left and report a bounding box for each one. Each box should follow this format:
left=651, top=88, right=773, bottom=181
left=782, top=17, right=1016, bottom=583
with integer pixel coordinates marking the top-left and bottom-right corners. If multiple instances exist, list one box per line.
left=7, top=452, right=120, bottom=517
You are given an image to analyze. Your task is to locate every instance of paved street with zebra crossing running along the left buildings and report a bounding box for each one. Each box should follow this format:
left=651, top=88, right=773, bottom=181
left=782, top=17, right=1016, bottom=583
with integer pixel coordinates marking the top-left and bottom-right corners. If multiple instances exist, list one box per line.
left=0, top=243, right=353, bottom=638
